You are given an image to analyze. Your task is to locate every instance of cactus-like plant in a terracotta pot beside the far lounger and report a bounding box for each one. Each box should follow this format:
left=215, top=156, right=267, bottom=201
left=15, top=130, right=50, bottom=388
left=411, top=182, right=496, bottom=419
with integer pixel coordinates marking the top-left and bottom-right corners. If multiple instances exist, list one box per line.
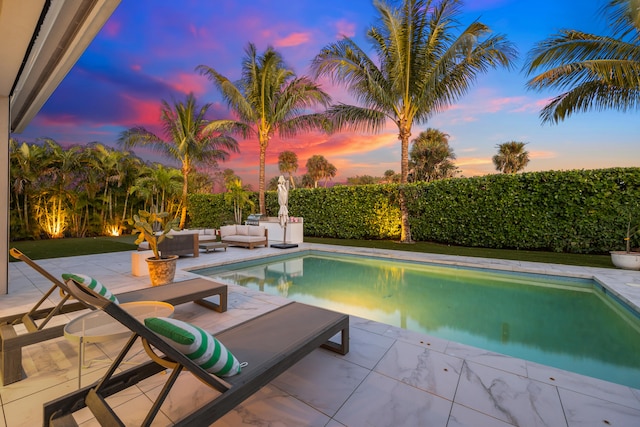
left=129, top=208, right=178, bottom=286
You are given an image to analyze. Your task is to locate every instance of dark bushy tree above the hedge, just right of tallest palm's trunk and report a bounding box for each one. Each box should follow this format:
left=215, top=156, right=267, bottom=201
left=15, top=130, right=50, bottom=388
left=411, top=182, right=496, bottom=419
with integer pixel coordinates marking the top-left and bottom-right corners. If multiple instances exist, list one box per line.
left=409, top=128, right=458, bottom=182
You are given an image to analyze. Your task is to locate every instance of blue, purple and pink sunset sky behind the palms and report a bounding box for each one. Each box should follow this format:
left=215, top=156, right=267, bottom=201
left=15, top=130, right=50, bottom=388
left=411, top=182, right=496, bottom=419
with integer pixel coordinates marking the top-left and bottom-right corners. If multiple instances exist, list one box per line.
left=12, top=0, right=640, bottom=189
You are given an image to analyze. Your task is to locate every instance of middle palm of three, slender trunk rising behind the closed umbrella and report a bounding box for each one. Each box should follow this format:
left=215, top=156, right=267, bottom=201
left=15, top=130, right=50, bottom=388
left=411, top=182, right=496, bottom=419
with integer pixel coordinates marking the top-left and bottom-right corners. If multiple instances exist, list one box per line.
left=197, top=43, right=331, bottom=214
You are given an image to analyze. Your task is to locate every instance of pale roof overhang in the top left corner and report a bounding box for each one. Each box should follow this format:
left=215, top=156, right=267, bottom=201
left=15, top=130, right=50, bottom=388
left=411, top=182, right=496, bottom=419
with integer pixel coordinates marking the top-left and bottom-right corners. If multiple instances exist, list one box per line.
left=0, top=0, right=120, bottom=133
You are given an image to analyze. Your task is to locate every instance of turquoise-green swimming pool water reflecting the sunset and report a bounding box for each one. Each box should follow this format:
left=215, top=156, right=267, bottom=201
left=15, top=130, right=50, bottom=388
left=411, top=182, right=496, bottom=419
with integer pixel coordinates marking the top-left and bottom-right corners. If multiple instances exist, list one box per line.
left=195, top=251, right=640, bottom=388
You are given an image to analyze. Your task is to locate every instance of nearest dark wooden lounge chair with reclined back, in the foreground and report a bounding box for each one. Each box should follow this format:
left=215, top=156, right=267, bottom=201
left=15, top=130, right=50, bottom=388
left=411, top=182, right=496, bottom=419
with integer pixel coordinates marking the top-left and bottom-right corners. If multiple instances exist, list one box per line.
left=44, top=276, right=349, bottom=426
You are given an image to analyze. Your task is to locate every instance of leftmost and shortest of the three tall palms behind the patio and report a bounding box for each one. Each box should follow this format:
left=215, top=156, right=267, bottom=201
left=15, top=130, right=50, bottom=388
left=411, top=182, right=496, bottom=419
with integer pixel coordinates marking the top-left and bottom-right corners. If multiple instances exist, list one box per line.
left=118, top=94, right=239, bottom=229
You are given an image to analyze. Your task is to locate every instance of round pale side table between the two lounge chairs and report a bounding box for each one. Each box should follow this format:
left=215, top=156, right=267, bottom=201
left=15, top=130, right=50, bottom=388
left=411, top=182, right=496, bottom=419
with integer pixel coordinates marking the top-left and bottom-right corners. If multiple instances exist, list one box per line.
left=64, top=301, right=173, bottom=388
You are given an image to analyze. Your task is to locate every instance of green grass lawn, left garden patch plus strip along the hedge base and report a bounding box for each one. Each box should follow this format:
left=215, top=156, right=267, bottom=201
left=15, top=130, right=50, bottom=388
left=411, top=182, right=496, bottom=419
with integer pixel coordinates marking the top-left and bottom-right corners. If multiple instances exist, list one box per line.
left=9, top=235, right=615, bottom=268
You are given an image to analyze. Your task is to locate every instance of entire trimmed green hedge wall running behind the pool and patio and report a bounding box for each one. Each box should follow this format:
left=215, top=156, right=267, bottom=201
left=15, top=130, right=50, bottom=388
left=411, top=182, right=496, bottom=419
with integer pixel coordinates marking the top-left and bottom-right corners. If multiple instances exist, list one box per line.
left=189, top=168, right=640, bottom=253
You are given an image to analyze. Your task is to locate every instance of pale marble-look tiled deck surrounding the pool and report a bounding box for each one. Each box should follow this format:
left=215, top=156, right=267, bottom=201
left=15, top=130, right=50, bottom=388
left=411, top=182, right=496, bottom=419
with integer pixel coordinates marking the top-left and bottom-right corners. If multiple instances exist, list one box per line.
left=0, top=244, right=640, bottom=427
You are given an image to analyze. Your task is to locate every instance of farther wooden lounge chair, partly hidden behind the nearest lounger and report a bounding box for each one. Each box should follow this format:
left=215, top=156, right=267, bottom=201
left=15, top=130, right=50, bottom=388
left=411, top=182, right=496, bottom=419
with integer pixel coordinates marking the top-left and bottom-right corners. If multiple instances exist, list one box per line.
left=0, top=248, right=227, bottom=385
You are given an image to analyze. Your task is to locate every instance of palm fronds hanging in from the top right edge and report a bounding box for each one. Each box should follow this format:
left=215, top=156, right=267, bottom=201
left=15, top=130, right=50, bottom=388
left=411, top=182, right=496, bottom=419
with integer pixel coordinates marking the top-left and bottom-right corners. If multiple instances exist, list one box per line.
left=525, top=0, right=640, bottom=123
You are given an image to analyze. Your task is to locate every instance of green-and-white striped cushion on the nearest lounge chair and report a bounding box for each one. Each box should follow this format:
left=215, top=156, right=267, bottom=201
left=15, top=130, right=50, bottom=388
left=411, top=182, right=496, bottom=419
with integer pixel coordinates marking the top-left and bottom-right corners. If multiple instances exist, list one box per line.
left=144, top=317, right=242, bottom=377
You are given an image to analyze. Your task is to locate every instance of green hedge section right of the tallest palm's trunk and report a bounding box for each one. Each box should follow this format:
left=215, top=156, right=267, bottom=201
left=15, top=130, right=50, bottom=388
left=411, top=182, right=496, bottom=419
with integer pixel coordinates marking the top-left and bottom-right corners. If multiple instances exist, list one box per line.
left=410, top=168, right=640, bottom=253
